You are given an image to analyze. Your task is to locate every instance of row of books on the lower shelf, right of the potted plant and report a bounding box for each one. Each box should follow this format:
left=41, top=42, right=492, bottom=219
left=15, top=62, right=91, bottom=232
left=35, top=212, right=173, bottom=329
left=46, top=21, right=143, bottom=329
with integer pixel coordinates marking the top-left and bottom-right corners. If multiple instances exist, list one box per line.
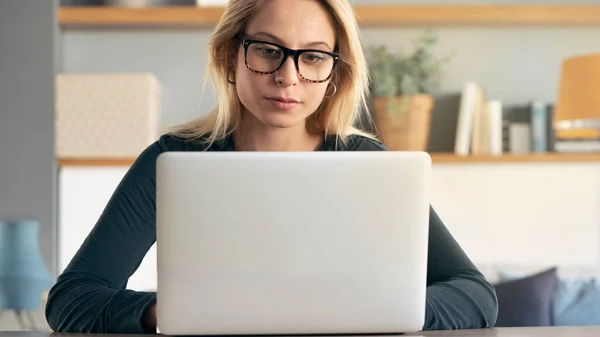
left=412, top=81, right=600, bottom=156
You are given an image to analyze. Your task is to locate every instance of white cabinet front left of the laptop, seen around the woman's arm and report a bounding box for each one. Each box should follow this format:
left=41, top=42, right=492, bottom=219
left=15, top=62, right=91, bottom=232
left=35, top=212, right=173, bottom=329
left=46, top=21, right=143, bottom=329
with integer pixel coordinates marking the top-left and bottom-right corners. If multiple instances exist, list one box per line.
left=58, top=167, right=156, bottom=290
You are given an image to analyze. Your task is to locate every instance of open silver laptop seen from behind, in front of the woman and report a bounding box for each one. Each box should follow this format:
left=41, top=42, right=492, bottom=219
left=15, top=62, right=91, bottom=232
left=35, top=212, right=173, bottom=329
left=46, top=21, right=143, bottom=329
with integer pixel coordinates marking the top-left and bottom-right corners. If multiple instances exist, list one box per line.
left=156, top=151, right=431, bottom=335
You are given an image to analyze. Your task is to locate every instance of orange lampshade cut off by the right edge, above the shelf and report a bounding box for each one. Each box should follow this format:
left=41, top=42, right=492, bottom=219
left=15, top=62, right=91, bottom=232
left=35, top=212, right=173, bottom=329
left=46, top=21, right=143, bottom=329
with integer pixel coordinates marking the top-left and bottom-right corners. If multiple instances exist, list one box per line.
left=554, top=54, right=600, bottom=139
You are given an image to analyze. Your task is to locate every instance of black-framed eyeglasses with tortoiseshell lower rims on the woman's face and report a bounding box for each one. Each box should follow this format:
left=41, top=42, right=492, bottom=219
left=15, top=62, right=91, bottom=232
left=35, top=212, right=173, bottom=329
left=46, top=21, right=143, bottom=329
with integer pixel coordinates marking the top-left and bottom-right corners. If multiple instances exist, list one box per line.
left=240, top=34, right=340, bottom=83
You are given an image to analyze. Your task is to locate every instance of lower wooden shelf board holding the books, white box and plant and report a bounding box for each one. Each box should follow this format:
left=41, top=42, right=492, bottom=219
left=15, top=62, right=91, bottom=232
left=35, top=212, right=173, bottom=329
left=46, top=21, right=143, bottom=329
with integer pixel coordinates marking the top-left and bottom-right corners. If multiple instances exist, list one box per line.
left=58, top=153, right=600, bottom=167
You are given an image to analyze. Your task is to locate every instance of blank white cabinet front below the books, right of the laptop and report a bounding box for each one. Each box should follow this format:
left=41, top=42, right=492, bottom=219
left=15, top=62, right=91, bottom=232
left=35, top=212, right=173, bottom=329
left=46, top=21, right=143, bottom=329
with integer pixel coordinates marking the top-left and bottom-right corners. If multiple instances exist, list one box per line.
left=432, top=162, right=600, bottom=266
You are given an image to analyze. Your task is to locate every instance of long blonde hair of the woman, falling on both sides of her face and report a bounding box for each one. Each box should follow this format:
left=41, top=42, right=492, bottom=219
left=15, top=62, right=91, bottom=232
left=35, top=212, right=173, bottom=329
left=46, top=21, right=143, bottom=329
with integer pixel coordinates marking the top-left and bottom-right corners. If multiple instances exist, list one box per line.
left=170, top=0, right=374, bottom=147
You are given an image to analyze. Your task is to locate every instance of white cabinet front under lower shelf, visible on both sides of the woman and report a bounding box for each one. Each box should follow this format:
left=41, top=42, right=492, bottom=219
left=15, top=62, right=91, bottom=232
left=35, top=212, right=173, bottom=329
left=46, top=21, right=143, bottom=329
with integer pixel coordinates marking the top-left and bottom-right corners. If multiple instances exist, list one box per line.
left=59, top=163, right=600, bottom=290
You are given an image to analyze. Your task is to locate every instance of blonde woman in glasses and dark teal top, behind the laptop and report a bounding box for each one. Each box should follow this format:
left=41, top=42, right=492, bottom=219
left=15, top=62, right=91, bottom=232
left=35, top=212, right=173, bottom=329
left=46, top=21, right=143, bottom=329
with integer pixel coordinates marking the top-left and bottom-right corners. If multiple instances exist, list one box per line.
left=46, top=0, right=497, bottom=333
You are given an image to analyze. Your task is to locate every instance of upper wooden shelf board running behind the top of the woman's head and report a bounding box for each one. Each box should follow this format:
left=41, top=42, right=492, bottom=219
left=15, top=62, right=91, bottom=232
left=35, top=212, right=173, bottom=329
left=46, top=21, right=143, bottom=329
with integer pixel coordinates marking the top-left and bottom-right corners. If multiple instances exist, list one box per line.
left=58, top=5, right=600, bottom=28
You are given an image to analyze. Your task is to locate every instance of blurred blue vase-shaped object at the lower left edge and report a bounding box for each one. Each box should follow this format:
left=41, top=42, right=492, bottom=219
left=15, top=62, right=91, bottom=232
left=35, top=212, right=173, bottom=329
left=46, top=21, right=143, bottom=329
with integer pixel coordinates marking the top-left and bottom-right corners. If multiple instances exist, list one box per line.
left=0, top=219, right=53, bottom=328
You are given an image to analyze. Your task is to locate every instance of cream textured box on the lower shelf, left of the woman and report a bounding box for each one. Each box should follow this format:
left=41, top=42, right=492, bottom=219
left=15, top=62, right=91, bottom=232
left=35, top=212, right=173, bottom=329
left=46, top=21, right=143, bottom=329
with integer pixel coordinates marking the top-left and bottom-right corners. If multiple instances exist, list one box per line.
left=55, top=73, right=161, bottom=158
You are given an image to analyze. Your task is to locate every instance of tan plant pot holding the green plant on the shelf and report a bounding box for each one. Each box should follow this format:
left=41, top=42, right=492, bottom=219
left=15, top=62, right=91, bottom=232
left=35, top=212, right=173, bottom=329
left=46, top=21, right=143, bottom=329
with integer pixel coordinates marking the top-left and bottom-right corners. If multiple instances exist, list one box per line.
left=372, top=94, right=434, bottom=151
